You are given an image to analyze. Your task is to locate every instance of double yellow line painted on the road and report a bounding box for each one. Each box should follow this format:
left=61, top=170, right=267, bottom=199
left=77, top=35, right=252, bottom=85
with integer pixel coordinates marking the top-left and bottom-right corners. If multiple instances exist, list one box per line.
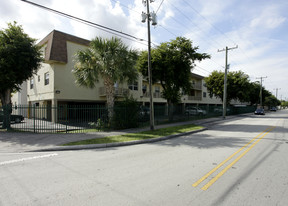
left=192, top=127, right=275, bottom=190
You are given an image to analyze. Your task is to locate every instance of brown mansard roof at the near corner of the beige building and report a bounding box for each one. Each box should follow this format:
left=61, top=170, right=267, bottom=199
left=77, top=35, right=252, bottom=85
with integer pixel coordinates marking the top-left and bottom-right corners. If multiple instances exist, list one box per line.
left=38, top=30, right=90, bottom=63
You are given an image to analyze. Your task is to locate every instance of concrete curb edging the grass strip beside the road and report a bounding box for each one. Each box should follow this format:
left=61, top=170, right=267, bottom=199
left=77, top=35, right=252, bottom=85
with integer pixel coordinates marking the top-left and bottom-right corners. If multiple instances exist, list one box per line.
left=29, top=128, right=207, bottom=152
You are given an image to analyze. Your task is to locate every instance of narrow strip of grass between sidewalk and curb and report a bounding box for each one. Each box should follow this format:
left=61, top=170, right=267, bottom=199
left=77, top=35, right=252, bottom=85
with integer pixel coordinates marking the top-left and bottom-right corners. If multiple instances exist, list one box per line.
left=62, top=124, right=203, bottom=146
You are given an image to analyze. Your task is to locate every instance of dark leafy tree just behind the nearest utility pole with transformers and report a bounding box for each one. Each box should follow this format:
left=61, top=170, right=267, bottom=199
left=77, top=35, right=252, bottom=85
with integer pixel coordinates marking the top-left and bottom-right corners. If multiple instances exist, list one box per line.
left=137, top=37, right=210, bottom=119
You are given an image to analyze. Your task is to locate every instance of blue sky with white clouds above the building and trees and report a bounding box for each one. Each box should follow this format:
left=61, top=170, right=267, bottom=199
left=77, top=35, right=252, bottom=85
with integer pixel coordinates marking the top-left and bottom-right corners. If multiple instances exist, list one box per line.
left=0, top=0, right=288, bottom=101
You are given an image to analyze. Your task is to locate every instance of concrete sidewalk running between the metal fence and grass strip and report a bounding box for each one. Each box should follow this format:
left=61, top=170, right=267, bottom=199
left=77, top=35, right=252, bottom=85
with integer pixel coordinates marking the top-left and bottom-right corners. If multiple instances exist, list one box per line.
left=0, top=115, right=245, bottom=153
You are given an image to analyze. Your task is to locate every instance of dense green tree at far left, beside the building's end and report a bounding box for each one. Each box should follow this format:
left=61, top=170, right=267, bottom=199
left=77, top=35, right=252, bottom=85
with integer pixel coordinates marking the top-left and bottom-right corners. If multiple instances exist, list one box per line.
left=0, top=22, right=42, bottom=128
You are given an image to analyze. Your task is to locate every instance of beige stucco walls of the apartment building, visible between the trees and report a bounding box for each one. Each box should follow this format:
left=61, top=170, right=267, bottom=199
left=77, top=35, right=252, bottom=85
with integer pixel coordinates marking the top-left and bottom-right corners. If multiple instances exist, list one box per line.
left=27, top=41, right=243, bottom=108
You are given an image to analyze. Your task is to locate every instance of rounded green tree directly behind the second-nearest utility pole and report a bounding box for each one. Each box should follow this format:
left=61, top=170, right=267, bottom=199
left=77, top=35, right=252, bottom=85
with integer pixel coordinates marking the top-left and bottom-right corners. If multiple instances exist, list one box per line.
left=205, top=71, right=250, bottom=104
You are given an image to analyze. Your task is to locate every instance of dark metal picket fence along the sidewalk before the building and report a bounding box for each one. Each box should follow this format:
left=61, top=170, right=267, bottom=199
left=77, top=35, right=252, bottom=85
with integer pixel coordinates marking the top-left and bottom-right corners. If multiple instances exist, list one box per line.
left=0, top=104, right=255, bottom=133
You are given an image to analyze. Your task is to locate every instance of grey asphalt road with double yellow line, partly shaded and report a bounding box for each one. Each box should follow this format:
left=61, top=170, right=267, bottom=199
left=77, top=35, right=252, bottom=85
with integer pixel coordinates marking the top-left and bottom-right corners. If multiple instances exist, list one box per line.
left=0, top=110, right=288, bottom=206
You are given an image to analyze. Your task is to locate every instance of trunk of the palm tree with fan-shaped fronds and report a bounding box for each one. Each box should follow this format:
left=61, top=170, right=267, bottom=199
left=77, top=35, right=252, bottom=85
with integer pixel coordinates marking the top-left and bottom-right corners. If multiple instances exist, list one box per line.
left=104, top=78, right=115, bottom=124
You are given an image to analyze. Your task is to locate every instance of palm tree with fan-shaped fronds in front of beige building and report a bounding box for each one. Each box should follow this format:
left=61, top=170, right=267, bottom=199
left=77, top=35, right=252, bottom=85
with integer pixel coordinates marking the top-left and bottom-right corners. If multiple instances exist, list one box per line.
left=73, top=37, right=138, bottom=121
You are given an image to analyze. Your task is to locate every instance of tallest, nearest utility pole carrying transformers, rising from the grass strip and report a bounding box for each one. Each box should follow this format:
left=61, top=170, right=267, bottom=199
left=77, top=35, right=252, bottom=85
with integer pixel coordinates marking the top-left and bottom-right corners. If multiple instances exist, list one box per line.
left=142, top=0, right=157, bottom=130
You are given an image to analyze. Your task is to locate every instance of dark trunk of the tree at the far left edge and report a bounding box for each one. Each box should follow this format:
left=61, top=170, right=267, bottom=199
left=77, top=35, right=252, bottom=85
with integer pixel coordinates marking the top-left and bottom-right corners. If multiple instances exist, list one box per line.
left=0, top=89, right=12, bottom=129
